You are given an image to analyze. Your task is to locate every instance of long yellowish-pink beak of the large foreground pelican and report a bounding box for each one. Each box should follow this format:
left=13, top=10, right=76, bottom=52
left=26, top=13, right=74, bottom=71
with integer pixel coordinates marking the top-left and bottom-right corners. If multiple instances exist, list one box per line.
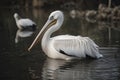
left=28, top=19, right=57, bottom=51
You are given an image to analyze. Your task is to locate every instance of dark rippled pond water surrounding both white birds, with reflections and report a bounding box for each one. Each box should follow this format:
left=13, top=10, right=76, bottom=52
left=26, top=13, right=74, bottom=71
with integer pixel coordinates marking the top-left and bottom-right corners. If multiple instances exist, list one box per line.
left=0, top=8, right=120, bottom=80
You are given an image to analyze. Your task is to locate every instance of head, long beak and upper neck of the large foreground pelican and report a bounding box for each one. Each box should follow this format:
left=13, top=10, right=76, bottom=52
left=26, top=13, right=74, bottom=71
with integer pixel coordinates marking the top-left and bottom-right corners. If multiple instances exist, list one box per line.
left=28, top=10, right=64, bottom=51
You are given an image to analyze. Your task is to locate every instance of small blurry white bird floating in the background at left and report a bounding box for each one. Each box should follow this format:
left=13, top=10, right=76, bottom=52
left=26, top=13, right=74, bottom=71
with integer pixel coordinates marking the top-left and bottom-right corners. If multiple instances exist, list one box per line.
left=14, top=13, right=36, bottom=31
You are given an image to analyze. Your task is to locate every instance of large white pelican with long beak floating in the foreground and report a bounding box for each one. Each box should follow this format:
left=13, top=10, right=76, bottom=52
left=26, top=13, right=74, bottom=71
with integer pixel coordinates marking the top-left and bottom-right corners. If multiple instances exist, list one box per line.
left=28, top=11, right=102, bottom=60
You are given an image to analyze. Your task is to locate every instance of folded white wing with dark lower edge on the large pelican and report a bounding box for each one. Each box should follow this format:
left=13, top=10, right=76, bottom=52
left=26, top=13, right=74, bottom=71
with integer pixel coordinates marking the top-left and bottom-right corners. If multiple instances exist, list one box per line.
left=54, top=35, right=100, bottom=57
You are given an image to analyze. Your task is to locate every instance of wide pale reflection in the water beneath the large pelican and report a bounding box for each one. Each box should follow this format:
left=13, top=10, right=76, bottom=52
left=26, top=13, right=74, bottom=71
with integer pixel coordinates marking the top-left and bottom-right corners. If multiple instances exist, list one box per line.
left=42, top=58, right=93, bottom=80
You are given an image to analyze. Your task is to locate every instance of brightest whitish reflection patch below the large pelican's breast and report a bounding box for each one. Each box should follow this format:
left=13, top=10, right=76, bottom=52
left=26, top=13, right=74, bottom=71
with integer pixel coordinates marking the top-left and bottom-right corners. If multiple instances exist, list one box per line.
left=42, top=58, right=67, bottom=80
